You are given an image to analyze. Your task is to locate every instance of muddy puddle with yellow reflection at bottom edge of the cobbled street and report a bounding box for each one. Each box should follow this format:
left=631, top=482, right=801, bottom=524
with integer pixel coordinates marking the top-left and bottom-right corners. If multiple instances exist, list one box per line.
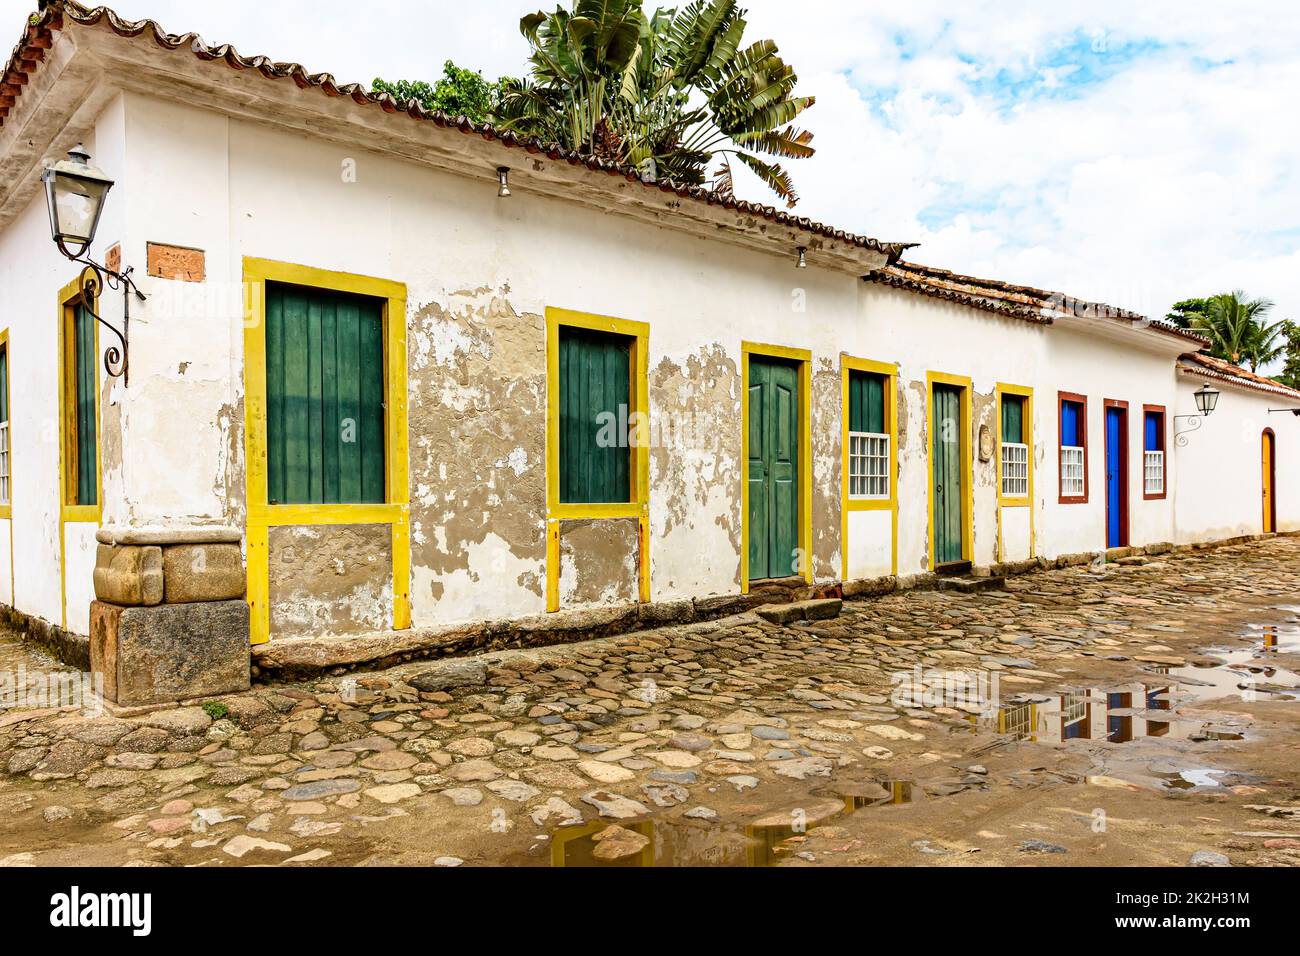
left=551, top=780, right=922, bottom=866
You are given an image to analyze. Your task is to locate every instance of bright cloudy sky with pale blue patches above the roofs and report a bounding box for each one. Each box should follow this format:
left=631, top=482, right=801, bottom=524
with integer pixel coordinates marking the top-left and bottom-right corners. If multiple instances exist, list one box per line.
left=30, top=0, right=1300, bottom=343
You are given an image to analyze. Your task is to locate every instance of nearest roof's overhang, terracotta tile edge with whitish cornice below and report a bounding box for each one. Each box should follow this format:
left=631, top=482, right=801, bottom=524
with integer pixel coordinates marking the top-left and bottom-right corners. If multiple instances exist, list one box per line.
left=0, top=3, right=907, bottom=276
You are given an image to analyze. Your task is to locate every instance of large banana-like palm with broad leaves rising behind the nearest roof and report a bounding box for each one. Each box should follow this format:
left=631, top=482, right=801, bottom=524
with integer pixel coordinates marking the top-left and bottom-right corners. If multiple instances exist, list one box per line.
left=501, top=0, right=814, bottom=206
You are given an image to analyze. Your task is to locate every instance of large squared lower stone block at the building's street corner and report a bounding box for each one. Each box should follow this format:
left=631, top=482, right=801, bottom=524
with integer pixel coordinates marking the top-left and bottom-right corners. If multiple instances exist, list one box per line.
left=90, top=601, right=250, bottom=706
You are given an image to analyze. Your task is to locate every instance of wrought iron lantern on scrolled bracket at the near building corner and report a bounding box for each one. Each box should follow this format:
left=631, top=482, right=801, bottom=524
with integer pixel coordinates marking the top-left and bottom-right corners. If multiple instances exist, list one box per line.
left=42, top=143, right=144, bottom=385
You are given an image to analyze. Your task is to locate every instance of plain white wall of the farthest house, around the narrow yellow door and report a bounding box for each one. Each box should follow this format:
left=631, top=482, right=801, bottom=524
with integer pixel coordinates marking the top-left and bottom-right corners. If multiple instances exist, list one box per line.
left=1174, top=375, right=1300, bottom=542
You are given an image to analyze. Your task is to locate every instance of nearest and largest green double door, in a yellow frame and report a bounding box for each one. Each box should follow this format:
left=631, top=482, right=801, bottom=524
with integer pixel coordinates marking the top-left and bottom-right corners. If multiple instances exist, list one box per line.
left=748, top=358, right=800, bottom=580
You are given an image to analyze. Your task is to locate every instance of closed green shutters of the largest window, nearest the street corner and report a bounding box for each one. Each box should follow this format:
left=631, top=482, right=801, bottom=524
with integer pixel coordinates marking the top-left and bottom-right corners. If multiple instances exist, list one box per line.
left=267, top=282, right=386, bottom=505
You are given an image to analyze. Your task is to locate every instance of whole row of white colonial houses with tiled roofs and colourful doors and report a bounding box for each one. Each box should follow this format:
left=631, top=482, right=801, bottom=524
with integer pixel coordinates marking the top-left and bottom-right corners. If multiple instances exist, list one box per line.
left=0, top=1, right=1300, bottom=689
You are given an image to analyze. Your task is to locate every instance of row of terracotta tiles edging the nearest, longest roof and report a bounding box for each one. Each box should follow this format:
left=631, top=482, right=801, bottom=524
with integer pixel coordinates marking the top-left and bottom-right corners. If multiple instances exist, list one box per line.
left=0, top=0, right=917, bottom=258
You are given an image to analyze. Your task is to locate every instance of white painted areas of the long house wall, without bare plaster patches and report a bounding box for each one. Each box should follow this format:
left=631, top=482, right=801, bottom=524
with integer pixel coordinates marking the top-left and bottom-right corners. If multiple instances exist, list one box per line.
left=0, top=85, right=1300, bottom=639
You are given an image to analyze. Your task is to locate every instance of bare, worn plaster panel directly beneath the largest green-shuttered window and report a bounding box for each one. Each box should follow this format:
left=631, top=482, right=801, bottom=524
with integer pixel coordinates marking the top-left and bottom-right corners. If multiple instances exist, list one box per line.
left=269, top=524, right=393, bottom=637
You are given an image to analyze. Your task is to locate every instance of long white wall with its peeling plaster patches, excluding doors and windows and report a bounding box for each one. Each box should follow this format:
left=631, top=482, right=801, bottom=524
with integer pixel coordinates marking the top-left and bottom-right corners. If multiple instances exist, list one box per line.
left=12, top=94, right=1300, bottom=635
